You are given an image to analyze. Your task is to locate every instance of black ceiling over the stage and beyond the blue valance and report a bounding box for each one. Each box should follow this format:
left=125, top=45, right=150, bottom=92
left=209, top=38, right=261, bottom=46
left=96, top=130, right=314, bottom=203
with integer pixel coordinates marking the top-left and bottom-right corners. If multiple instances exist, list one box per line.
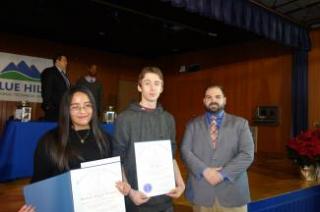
left=0, top=0, right=320, bottom=58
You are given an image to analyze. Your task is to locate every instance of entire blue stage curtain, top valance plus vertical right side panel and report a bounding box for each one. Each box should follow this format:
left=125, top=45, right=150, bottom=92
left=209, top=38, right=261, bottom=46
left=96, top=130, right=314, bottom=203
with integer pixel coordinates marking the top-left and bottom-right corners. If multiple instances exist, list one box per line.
left=161, top=0, right=311, bottom=135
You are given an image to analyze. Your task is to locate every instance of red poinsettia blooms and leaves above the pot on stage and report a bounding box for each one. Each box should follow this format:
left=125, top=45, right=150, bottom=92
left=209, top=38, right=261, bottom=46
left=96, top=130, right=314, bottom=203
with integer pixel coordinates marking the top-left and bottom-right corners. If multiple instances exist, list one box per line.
left=287, top=128, right=320, bottom=167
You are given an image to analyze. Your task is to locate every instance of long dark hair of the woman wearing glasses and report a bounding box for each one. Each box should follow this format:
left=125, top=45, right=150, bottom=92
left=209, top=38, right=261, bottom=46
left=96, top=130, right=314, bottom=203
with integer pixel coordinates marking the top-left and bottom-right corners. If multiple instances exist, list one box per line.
left=47, top=86, right=110, bottom=170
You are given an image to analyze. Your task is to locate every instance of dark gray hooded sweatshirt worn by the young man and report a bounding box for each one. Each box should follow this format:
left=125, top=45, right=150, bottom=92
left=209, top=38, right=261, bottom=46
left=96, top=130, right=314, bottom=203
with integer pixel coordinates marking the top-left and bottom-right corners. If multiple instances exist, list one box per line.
left=112, top=103, right=176, bottom=212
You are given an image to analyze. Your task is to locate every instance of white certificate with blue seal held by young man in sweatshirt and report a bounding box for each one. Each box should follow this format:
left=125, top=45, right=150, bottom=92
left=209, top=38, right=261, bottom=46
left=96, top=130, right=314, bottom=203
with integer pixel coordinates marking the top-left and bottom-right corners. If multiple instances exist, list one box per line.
left=134, top=140, right=175, bottom=197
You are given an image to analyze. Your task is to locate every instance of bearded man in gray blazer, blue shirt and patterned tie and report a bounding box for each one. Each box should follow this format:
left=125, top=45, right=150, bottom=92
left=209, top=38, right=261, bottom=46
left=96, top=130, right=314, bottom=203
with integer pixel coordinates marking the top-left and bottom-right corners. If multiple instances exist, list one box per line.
left=181, top=85, right=254, bottom=212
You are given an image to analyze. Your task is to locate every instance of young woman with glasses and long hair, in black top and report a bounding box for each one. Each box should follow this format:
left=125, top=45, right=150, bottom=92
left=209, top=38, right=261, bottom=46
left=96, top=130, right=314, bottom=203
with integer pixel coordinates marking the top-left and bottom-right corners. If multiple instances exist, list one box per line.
left=22, top=86, right=130, bottom=211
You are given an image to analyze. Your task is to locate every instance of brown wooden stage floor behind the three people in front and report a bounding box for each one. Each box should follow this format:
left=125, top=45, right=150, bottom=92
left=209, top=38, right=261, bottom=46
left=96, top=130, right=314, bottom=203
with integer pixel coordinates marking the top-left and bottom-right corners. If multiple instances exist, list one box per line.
left=0, top=154, right=316, bottom=212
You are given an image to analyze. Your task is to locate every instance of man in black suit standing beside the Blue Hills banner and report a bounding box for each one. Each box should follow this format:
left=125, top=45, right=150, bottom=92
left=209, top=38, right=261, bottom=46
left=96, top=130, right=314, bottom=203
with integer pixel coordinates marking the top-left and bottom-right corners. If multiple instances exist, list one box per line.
left=41, top=54, right=70, bottom=121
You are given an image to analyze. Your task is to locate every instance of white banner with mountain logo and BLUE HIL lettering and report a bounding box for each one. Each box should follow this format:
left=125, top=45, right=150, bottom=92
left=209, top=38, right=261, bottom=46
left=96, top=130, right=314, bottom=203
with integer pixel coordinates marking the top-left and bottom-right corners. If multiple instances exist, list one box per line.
left=0, top=52, right=53, bottom=102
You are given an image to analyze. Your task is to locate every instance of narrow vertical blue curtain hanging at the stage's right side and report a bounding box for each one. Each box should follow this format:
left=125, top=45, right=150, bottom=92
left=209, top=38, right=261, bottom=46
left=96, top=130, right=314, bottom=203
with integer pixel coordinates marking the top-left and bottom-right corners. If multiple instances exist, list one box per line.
left=292, top=50, right=308, bottom=136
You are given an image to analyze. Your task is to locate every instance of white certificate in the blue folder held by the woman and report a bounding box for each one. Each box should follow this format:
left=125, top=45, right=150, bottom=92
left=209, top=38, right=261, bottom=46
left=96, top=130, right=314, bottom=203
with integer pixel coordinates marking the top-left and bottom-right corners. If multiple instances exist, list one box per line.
left=71, top=157, right=125, bottom=212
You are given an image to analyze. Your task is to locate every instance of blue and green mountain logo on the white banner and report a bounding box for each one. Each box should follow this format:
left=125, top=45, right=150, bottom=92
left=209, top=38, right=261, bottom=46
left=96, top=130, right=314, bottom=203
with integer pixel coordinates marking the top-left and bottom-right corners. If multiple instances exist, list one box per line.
left=0, top=61, right=40, bottom=82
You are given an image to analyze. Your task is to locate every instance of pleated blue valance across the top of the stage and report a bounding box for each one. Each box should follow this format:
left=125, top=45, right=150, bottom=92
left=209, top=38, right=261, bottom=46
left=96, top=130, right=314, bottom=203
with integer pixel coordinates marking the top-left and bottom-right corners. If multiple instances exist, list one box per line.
left=161, top=0, right=310, bottom=51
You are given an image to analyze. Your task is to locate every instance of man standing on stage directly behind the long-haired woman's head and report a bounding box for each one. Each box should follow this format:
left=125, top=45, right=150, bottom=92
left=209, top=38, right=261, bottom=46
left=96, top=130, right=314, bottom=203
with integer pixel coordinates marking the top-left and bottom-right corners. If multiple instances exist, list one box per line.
left=77, top=64, right=103, bottom=116
